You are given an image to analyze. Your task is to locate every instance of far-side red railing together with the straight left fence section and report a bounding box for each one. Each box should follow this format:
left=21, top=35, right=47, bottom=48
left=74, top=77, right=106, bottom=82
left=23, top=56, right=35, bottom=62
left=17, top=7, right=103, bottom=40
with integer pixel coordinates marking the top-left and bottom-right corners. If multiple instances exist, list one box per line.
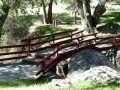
left=0, top=30, right=82, bottom=61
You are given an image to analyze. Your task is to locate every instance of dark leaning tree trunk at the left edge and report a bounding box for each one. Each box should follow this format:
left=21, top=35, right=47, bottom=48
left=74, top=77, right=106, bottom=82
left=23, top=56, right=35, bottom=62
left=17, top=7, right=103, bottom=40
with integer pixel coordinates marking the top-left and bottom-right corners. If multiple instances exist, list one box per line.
left=0, top=6, right=9, bottom=38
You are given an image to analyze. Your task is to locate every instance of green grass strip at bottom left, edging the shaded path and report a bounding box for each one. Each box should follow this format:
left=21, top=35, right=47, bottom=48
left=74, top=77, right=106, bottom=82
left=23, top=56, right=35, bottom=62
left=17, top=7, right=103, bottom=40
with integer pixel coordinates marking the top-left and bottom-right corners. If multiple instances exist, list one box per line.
left=0, top=79, right=51, bottom=90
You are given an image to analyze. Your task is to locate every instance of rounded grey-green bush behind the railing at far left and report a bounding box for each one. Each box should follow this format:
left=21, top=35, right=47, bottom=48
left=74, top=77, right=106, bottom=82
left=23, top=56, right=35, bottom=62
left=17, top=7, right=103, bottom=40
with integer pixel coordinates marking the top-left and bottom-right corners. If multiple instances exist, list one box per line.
left=2, top=17, right=30, bottom=45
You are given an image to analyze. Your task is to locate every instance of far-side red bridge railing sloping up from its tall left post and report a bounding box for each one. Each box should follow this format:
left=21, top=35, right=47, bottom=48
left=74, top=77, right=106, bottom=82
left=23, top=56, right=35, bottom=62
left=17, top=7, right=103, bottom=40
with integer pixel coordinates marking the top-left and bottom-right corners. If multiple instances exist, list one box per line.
left=21, top=29, right=83, bottom=56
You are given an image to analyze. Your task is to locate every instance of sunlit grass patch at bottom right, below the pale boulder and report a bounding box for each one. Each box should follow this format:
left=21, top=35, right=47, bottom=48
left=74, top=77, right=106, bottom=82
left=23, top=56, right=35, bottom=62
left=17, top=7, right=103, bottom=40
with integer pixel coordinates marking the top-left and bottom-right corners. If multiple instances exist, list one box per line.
left=64, top=81, right=120, bottom=90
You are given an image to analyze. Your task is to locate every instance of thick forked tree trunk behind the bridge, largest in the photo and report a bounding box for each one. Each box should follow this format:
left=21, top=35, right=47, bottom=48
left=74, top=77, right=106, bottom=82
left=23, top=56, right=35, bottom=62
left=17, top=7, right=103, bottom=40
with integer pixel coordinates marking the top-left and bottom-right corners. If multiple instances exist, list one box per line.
left=75, top=0, right=106, bottom=32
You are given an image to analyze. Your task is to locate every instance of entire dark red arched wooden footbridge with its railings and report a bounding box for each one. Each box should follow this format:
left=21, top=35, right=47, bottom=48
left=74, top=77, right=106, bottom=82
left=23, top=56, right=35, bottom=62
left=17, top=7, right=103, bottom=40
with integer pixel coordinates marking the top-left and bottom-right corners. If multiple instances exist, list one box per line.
left=0, top=30, right=120, bottom=79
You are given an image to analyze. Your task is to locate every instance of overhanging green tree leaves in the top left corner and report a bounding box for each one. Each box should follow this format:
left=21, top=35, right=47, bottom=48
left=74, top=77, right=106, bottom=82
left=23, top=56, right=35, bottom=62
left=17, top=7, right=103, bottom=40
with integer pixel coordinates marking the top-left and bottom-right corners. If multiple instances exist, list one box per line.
left=0, top=0, right=42, bottom=15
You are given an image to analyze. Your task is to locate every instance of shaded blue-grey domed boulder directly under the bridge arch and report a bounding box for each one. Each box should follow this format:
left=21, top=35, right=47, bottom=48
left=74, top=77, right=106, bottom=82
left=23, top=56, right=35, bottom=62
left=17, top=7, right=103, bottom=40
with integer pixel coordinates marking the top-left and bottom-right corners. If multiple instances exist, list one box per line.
left=68, top=49, right=116, bottom=75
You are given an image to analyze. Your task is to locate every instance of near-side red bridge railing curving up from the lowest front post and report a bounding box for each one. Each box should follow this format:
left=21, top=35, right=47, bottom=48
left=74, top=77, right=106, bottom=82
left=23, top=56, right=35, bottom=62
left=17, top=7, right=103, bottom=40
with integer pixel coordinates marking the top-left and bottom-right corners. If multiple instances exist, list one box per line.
left=36, top=33, right=98, bottom=77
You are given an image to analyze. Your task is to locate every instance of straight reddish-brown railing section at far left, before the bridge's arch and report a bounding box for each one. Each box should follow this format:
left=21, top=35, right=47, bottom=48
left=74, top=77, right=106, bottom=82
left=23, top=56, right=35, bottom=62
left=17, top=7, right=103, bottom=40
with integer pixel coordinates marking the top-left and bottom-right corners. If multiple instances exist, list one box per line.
left=0, top=44, right=27, bottom=61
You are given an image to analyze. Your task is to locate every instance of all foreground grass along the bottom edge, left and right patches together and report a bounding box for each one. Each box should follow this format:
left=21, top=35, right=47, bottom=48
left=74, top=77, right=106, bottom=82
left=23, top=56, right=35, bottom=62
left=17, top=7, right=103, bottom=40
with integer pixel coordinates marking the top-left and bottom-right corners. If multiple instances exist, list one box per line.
left=0, top=79, right=120, bottom=90
